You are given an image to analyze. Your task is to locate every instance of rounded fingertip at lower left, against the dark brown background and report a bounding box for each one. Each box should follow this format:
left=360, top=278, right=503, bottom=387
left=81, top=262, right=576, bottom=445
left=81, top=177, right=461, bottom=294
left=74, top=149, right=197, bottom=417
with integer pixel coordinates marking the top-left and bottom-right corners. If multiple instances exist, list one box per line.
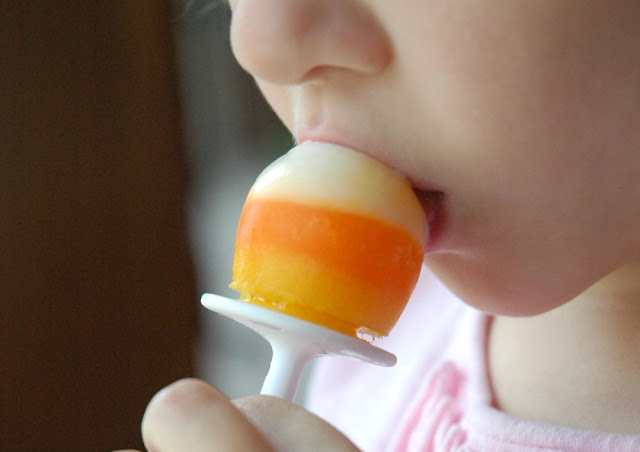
left=142, top=379, right=273, bottom=452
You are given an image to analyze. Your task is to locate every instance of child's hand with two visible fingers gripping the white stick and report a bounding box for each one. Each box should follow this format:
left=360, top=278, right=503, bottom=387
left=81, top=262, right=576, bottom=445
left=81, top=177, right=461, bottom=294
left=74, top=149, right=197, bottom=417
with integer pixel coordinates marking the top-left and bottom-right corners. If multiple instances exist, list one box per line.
left=115, top=379, right=358, bottom=452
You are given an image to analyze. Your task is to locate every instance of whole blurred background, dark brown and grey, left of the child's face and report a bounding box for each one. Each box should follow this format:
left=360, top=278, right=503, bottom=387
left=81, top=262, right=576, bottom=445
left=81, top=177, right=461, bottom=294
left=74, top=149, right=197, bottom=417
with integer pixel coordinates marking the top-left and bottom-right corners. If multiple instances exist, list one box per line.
left=0, top=0, right=290, bottom=452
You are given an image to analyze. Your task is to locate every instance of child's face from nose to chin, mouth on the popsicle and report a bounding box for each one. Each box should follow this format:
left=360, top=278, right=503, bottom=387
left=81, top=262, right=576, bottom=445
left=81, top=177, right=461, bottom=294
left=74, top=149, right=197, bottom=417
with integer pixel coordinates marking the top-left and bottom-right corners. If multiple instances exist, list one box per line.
left=231, top=0, right=640, bottom=314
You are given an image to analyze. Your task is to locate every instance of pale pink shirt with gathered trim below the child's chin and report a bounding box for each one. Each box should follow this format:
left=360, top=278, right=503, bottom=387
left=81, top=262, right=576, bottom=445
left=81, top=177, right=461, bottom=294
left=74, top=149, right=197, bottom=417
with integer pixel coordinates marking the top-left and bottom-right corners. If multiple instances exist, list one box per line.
left=307, top=266, right=640, bottom=452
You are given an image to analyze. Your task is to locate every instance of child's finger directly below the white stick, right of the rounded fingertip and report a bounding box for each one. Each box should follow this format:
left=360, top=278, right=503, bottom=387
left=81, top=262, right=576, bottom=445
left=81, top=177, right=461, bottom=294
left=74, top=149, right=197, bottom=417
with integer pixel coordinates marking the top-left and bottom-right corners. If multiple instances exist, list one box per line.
left=233, top=396, right=358, bottom=452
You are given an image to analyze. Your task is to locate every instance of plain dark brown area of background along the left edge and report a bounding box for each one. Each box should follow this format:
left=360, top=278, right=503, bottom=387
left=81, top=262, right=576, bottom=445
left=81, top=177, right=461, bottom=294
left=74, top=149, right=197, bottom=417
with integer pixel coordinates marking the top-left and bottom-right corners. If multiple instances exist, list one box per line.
left=0, top=0, right=197, bottom=452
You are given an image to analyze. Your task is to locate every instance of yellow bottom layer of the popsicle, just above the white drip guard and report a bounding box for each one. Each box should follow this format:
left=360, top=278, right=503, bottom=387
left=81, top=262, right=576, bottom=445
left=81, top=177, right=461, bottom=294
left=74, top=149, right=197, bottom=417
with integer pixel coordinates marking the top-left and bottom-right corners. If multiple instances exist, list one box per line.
left=230, top=247, right=406, bottom=337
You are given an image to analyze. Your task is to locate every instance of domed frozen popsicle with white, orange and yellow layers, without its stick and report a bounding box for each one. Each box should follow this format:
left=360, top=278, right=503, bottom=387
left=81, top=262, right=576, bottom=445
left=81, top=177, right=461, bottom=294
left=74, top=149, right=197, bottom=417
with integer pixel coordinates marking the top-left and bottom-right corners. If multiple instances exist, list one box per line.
left=230, top=142, right=427, bottom=337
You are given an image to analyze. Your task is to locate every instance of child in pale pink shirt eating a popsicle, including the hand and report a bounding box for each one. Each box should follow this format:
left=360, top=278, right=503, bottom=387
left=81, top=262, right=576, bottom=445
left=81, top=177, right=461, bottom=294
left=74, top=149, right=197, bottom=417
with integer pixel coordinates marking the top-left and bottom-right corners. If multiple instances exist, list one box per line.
left=119, top=0, right=640, bottom=452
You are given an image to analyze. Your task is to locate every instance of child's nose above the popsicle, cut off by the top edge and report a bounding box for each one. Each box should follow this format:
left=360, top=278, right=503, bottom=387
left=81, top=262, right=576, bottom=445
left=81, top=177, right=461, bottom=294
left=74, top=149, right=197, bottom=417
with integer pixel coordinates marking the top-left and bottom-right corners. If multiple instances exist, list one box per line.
left=231, top=0, right=392, bottom=84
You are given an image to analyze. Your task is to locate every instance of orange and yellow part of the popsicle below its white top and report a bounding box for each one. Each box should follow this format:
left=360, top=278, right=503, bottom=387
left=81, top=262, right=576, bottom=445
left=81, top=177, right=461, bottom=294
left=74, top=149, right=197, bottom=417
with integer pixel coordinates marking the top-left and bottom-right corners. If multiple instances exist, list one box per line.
left=231, top=197, right=423, bottom=336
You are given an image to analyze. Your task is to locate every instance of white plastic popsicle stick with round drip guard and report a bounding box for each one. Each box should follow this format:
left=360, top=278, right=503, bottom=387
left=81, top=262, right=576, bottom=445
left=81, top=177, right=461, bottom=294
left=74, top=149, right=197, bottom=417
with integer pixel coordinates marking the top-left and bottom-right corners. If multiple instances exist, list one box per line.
left=201, top=294, right=396, bottom=401
